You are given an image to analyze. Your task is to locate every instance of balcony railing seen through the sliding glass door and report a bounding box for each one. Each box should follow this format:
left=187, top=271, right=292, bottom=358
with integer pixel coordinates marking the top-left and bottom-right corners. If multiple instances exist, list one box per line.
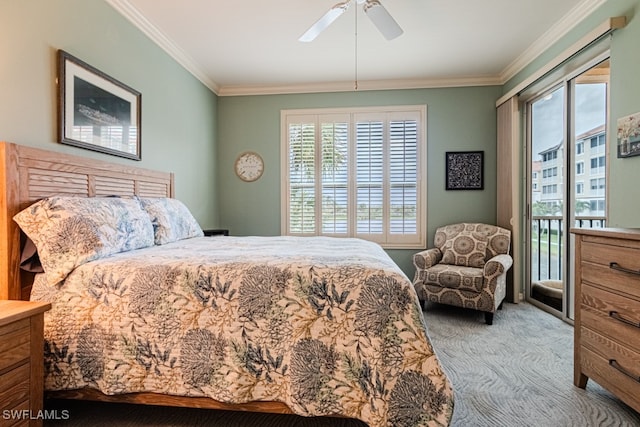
left=531, top=216, right=606, bottom=282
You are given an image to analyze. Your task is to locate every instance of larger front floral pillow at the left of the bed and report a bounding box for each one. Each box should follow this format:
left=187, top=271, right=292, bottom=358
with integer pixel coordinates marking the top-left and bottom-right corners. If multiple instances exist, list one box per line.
left=13, top=196, right=154, bottom=285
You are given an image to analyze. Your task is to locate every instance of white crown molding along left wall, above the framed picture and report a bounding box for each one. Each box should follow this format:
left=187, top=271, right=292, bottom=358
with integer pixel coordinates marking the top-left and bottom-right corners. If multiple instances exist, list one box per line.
left=105, top=0, right=220, bottom=94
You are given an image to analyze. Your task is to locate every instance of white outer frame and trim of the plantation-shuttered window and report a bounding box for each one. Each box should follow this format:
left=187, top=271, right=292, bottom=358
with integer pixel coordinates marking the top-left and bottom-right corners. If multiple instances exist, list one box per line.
left=280, top=105, right=427, bottom=249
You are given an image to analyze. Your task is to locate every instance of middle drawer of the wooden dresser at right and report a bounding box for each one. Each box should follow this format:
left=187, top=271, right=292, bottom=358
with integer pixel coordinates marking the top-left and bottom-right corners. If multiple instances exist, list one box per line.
left=580, top=283, right=640, bottom=352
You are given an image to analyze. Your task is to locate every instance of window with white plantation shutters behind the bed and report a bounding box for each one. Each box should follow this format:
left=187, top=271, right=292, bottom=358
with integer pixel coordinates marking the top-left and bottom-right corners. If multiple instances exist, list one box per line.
left=281, top=106, right=426, bottom=248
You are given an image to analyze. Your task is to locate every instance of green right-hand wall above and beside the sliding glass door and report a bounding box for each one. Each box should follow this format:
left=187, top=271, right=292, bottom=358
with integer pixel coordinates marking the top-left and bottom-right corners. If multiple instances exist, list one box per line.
left=504, top=0, right=640, bottom=228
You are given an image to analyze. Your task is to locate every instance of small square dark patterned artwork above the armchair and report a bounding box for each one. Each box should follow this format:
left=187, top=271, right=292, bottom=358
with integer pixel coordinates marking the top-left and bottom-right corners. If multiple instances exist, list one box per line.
left=446, top=151, right=484, bottom=190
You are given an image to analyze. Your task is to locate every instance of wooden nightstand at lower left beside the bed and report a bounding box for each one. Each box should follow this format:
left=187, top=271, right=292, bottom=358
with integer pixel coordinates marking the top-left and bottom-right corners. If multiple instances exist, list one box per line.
left=0, top=300, right=51, bottom=426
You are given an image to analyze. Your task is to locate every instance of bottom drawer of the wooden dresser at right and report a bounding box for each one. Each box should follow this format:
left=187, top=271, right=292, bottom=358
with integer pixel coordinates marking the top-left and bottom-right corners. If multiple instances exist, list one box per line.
left=580, top=328, right=640, bottom=412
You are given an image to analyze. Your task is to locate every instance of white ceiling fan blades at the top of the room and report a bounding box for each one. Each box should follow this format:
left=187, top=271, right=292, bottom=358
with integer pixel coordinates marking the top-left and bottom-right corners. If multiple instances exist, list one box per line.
left=298, top=0, right=403, bottom=42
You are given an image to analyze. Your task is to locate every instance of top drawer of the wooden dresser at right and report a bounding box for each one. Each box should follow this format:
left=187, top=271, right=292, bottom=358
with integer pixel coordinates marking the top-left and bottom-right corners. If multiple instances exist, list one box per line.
left=581, top=242, right=640, bottom=298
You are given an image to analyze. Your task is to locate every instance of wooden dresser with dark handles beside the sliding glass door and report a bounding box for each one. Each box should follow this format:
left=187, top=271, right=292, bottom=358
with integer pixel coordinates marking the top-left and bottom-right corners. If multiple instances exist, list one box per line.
left=571, top=228, right=640, bottom=412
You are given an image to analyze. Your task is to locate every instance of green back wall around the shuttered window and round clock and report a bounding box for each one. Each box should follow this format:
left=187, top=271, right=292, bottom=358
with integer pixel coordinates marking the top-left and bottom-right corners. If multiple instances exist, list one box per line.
left=217, top=86, right=502, bottom=277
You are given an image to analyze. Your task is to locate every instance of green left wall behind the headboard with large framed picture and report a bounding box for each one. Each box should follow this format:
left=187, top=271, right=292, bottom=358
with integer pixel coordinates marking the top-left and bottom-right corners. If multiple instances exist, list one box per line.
left=0, top=0, right=218, bottom=227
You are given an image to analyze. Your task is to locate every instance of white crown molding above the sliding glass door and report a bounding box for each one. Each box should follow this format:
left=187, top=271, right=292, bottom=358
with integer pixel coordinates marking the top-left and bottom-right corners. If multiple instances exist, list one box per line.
left=500, top=0, right=607, bottom=84
